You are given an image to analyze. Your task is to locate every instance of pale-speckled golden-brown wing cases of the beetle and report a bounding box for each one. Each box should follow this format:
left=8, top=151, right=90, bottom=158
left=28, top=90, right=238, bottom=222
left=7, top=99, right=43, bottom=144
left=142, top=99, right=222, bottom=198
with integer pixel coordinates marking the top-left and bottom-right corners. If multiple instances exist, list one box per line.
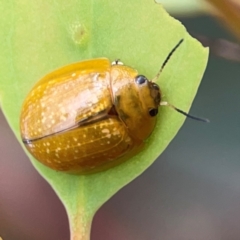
left=21, top=58, right=154, bottom=173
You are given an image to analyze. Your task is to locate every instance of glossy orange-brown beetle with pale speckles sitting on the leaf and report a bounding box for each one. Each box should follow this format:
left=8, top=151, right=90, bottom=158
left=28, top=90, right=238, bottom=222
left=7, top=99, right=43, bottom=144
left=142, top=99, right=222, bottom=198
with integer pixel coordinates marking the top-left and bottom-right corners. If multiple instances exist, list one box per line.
left=20, top=40, right=204, bottom=174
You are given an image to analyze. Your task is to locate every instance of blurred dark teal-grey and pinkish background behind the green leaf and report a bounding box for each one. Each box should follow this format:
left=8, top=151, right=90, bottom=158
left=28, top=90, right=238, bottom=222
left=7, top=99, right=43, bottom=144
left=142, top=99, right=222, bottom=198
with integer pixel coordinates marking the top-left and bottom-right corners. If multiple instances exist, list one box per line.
left=0, top=17, right=240, bottom=240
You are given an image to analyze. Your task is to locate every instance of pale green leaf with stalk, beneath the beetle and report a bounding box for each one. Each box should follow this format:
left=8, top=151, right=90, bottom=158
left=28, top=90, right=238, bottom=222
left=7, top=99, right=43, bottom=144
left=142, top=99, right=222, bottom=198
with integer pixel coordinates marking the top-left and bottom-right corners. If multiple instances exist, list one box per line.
left=0, top=0, right=208, bottom=240
